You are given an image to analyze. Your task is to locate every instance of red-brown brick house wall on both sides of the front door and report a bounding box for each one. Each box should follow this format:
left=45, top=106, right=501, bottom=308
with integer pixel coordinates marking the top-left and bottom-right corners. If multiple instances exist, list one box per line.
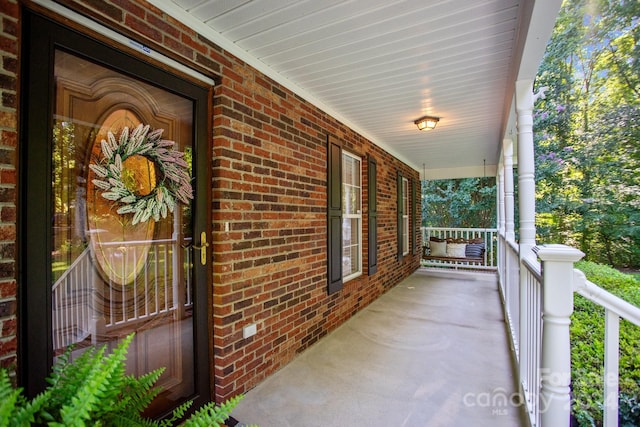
left=6, top=0, right=419, bottom=400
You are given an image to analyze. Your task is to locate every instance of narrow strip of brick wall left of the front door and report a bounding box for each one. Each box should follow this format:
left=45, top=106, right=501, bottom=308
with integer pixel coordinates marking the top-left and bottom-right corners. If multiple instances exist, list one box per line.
left=0, top=0, right=20, bottom=370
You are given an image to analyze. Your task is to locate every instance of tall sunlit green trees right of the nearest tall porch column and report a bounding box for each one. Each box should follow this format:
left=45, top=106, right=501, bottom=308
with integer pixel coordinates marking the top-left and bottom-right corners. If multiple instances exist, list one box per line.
left=534, top=0, right=640, bottom=267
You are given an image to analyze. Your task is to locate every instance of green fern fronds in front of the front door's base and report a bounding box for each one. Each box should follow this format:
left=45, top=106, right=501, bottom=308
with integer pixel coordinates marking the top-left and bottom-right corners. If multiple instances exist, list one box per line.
left=0, top=334, right=242, bottom=427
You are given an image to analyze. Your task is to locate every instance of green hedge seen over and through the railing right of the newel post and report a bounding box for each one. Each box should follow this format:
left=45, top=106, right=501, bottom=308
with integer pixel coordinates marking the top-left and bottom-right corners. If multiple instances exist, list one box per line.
left=571, top=261, right=640, bottom=426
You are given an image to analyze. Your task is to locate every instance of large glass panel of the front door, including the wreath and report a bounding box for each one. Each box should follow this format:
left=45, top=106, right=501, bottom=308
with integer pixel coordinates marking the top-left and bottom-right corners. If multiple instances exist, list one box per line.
left=51, top=51, right=195, bottom=416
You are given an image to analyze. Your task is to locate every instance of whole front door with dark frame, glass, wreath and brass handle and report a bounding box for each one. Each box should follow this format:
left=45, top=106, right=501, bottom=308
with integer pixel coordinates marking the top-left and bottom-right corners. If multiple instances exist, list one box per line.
left=20, top=10, right=210, bottom=416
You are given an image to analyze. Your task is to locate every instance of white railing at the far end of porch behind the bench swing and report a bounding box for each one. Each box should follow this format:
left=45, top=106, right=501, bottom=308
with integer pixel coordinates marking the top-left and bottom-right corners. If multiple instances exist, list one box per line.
left=421, top=227, right=498, bottom=270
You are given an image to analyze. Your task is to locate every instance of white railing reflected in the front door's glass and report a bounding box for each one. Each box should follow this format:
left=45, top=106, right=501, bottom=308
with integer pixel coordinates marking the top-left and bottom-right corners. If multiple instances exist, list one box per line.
left=51, top=239, right=192, bottom=351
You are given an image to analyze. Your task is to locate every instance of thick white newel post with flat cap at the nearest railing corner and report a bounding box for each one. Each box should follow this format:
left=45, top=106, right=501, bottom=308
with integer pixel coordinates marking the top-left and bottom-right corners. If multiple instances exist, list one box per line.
left=535, top=245, right=584, bottom=427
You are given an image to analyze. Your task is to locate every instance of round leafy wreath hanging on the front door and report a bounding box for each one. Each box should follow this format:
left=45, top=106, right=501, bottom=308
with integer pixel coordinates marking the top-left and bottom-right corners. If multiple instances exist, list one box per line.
left=89, top=124, right=193, bottom=225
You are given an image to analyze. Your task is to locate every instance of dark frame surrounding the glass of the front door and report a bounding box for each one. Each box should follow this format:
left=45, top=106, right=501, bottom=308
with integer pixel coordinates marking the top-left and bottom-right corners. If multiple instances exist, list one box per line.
left=17, top=9, right=212, bottom=412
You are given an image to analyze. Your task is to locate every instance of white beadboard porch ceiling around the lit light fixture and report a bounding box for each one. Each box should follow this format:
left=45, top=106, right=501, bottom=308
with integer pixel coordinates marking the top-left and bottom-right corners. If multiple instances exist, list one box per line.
left=151, top=0, right=561, bottom=179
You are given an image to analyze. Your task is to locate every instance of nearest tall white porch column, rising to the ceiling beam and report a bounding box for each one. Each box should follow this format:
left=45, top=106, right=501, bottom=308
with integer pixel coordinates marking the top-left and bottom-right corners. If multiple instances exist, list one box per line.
left=516, top=80, right=536, bottom=256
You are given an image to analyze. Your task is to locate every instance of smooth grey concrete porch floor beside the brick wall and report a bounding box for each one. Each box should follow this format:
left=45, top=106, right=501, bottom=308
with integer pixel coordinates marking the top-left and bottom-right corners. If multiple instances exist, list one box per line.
left=232, top=269, right=527, bottom=427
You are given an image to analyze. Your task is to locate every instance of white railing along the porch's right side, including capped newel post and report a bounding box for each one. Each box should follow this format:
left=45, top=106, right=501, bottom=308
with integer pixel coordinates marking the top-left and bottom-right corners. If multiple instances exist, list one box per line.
left=499, top=239, right=640, bottom=427
